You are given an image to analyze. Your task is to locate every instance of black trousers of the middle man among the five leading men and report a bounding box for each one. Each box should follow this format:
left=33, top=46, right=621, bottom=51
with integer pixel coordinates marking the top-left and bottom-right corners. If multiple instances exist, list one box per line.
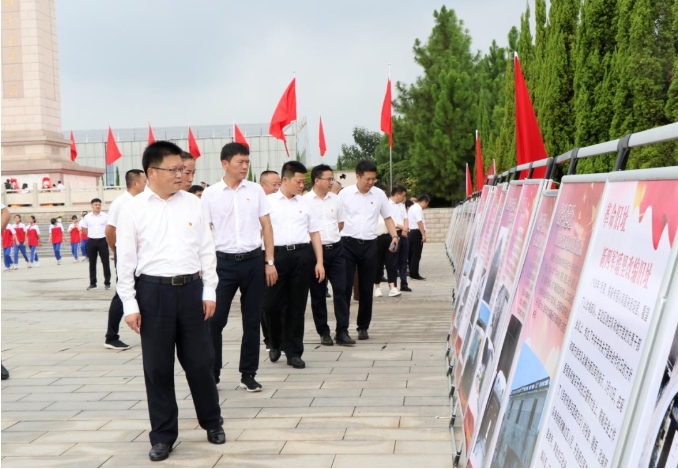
left=264, top=246, right=317, bottom=358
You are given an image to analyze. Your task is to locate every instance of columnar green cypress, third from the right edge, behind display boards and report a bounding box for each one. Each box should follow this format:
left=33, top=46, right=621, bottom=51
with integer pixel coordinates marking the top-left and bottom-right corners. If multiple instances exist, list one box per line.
left=537, top=0, right=579, bottom=156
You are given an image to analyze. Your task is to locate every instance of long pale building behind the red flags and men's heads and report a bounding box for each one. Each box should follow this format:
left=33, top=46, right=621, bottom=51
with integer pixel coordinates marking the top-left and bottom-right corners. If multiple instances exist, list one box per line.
left=63, top=117, right=309, bottom=186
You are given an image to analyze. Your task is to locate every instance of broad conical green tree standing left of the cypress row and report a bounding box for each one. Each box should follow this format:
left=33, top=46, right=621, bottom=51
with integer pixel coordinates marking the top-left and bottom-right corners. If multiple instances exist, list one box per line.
left=410, top=6, right=478, bottom=200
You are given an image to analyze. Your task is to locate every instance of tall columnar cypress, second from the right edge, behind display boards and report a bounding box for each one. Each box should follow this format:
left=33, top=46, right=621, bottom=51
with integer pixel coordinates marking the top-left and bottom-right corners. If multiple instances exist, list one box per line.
left=574, top=0, right=618, bottom=173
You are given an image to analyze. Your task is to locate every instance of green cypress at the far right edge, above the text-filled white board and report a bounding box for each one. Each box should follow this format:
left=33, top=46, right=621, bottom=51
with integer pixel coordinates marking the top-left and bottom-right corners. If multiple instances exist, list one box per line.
left=610, top=0, right=676, bottom=169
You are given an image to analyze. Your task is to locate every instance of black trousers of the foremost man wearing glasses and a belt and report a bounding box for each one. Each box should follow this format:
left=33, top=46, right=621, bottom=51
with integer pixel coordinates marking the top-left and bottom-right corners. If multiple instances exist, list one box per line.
left=138, top=278, right=221, bottom=445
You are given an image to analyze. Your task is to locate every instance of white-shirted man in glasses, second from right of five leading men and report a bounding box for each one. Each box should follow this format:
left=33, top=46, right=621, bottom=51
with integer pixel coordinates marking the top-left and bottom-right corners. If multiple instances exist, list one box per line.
left=304, top=164, right=355, bottom=345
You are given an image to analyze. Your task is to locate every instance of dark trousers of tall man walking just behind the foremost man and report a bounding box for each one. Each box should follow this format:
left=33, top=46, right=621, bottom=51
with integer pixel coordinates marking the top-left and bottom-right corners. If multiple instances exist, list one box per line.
left=209, top=256, right=266, bottom=377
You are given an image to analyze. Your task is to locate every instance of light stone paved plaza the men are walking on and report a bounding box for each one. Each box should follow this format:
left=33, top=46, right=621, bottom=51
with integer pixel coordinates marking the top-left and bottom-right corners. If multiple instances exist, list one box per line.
left=0, top=244, right=452, bottom=467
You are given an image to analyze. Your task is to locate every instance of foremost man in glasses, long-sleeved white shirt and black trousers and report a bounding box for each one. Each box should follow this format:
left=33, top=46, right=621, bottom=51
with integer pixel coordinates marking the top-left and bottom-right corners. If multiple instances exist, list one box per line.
left=116, top=141, right=226, bottom=461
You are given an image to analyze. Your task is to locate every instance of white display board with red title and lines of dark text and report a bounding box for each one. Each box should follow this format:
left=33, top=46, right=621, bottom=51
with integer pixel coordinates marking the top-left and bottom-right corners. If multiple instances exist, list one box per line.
left=537, top=176, right=678, bottom=467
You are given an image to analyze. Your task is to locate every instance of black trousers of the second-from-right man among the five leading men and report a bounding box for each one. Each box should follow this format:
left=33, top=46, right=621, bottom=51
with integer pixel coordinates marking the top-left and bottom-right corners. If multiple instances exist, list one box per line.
left=311, top=244, right=348, bottom=336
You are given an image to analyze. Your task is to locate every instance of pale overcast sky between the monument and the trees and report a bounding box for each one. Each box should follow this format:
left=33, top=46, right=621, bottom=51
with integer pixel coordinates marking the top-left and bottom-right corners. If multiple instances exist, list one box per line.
left=56, top=0, right=533, bottom=164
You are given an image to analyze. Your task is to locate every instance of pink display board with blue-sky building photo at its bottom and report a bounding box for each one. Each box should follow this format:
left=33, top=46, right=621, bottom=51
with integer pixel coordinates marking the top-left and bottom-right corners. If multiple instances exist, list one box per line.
left=492, top=181, right=605, bottom=467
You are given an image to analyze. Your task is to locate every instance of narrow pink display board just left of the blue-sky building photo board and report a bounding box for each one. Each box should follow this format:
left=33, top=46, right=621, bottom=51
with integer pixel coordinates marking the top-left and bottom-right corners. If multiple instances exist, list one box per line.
left=469, top=193, right=556, bottom=466
